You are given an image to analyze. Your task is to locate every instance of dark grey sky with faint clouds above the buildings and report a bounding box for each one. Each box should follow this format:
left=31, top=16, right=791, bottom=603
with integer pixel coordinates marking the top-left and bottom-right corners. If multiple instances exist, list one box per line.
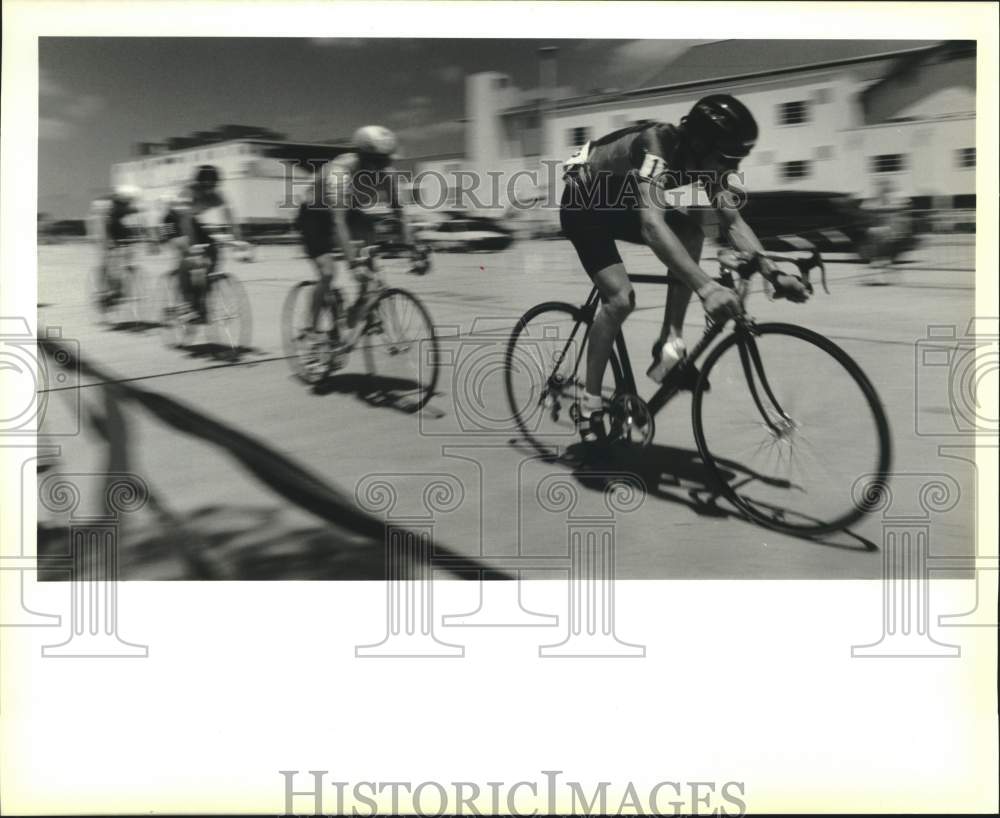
left=38, top=37, right=695, bottom=218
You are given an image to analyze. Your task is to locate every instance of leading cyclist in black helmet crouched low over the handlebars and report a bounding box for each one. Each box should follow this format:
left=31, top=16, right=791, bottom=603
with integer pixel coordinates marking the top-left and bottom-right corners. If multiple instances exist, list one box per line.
left=560, top=94, right=808, bottom=442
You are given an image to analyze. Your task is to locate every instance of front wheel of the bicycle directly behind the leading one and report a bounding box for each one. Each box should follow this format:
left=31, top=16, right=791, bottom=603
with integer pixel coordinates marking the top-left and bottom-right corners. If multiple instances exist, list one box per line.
left=361, top=288, right=439, bottom=412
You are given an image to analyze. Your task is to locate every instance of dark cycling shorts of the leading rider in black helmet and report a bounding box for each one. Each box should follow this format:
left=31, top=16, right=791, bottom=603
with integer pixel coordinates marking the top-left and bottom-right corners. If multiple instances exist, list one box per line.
left=559, top=176, right=702, bottom=278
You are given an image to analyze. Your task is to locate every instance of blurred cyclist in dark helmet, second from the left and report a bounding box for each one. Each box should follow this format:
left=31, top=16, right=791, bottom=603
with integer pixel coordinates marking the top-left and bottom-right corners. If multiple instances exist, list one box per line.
left=163, top=165, right=247, bottom=322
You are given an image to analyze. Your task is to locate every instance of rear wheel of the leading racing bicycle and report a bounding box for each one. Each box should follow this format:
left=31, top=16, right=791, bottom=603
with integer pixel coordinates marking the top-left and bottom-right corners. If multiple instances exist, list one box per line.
left=504, top=301, right=622, bottom=457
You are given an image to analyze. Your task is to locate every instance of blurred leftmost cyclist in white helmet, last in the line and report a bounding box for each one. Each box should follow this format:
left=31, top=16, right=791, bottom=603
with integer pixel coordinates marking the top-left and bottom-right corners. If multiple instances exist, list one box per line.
left=90, top=185, right=155, bottom=309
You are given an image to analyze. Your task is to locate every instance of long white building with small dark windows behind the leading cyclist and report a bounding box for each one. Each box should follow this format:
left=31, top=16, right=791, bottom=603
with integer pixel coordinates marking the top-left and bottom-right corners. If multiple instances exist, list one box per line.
left=415, top=40, right=975, bottom=218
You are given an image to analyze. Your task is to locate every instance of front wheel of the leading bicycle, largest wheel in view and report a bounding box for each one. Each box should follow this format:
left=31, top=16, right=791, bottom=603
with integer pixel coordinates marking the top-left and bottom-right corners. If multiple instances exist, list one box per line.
left=691, top=324, right=891, bottom=536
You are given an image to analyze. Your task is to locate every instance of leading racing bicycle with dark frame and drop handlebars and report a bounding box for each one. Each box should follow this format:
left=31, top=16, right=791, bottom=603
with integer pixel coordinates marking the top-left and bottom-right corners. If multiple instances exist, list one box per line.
left=504, top=250, right=892, bottom=537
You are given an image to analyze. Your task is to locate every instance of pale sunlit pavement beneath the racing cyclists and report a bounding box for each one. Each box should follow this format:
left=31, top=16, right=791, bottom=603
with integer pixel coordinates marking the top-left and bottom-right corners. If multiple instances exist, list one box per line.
left=38, top=237, right=975, bottom=580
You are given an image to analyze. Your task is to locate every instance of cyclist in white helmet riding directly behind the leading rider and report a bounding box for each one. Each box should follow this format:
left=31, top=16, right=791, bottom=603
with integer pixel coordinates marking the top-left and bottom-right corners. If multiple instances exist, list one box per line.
left=295, top=125, right=422, bottom=360
